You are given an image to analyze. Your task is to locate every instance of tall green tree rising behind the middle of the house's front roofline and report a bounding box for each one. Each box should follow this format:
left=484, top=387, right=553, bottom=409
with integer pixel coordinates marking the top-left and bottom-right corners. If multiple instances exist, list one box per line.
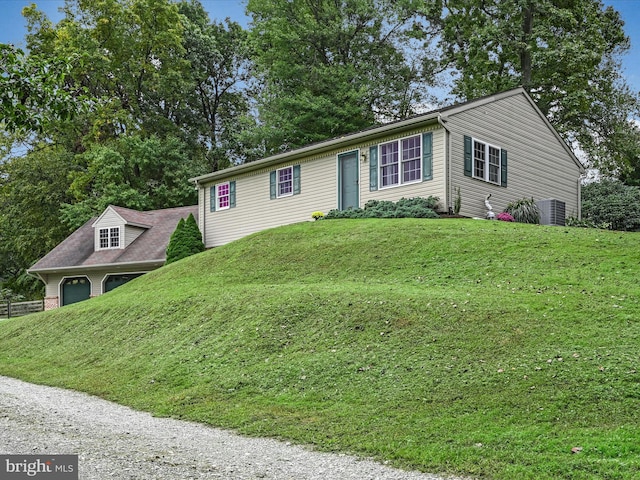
left=247, top=0, right=436, bottom=153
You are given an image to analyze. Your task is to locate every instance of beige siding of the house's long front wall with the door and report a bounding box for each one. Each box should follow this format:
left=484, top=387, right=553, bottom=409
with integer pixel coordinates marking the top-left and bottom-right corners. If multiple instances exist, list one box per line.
left=198, top=124, right=445, bottom=248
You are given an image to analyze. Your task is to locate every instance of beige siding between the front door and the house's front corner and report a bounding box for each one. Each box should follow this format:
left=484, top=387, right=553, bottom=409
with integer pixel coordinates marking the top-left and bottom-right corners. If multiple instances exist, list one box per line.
left=360, top=125, right=446, bottom=210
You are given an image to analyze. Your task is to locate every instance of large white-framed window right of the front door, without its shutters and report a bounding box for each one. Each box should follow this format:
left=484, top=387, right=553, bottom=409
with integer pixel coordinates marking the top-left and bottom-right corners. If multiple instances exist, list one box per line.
left=379, top=135, right=422, bottom=188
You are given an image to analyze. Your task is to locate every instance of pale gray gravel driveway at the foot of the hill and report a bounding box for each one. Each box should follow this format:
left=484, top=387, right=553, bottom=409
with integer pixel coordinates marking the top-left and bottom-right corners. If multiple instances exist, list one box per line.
left=0, top=376, right=464, bottom=480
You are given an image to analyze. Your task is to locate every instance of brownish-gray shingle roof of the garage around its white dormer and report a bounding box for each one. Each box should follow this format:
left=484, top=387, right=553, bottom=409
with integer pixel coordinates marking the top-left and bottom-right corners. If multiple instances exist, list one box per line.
left=29, top=205, right=198, bottom=273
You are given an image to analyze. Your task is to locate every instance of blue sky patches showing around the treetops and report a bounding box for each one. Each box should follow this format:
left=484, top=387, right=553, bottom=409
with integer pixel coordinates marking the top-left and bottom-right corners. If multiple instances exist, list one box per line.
left=0, top=0, right=640, bottom=92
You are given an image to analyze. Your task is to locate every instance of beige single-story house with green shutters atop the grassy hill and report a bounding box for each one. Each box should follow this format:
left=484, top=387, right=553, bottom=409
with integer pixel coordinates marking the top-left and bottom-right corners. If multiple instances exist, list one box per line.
left=192, top=88, right=585, bottom=248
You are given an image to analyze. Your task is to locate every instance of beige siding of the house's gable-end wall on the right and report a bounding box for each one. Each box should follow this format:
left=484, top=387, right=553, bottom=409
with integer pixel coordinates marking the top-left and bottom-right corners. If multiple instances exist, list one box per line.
left=446, top=94, right=580, bottom=217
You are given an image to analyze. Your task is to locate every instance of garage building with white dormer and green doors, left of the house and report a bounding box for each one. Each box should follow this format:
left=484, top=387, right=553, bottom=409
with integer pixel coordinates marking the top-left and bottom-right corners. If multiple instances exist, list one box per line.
left=28, top=205, right=198, bottom=310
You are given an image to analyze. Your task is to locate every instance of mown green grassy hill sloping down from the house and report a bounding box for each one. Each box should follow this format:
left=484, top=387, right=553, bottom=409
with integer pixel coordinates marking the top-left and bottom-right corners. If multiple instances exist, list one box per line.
left=0, top=219, right=640, bottom=479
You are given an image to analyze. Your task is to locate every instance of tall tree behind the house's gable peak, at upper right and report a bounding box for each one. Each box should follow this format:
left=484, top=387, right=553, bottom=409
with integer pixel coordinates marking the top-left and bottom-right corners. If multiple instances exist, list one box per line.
left=432, top=0, right=637, bottom=175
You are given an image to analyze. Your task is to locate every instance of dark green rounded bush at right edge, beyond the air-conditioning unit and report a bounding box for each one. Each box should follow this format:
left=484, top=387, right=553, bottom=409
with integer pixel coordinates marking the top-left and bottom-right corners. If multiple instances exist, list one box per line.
left=582, top=179, right=640, bottom=231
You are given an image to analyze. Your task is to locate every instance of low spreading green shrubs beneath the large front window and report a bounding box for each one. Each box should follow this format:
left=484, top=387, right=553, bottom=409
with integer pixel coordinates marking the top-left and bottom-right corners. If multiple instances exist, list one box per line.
left=324, top=197, right=438, bottom=219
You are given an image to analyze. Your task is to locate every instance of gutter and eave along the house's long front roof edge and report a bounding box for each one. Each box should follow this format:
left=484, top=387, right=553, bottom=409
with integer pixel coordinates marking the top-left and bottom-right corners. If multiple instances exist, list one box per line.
left=189, top=111, right=440, bottom=186
